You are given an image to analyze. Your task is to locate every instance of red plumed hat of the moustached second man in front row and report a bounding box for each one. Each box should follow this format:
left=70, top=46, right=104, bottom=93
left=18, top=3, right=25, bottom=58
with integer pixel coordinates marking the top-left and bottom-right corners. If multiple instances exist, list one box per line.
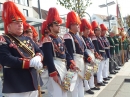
left=46, top=7, right=62, bottom=25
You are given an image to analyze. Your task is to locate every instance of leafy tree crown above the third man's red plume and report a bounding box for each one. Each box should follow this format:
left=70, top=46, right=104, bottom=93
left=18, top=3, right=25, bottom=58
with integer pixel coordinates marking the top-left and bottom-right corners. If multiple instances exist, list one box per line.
left=57, top=0, right=92, bottom=18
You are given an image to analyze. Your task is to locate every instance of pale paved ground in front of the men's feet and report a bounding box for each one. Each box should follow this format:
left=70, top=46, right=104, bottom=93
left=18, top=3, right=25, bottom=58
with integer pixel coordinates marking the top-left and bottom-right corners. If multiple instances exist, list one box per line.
left=0, top=61, right=130, bottom=97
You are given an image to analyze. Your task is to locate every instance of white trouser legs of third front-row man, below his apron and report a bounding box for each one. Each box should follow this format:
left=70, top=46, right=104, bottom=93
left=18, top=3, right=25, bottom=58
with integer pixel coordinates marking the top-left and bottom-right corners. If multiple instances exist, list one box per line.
left=71, top=77, right=84, bottom=97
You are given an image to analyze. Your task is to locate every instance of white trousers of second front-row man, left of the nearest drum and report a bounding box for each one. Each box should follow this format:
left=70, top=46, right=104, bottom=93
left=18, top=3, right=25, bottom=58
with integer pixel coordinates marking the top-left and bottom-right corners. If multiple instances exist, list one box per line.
left=47, top=77, right=67, bottom=97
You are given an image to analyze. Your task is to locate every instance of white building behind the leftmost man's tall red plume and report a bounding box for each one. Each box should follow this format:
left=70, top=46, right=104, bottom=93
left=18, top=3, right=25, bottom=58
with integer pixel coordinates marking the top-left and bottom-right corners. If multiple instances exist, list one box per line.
left=0, top=0, right=42, bottom=34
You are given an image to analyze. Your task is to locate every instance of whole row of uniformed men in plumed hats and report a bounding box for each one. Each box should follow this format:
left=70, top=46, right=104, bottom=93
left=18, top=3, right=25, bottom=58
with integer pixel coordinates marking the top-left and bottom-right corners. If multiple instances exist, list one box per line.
left=0, top=1, right=128, bottom=97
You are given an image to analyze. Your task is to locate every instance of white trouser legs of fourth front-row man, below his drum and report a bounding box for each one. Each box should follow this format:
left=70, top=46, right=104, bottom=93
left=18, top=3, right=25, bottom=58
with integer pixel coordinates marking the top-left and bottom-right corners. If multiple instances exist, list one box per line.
left=84, top=73, right=95, bottom=91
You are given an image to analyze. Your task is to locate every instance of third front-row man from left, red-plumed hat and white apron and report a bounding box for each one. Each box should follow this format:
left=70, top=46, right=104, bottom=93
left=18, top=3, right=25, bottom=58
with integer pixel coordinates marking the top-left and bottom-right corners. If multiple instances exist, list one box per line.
left=64, top=11, right=92, bottom=97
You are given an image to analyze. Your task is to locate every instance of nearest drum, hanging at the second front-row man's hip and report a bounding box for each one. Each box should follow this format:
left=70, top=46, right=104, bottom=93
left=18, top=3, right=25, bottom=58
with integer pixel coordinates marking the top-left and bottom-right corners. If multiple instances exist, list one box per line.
left=62, top=71, right=78, bottom=92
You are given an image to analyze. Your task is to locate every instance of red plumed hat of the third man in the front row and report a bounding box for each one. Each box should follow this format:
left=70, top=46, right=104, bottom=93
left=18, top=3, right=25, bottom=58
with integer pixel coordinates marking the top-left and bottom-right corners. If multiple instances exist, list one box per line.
left=66, top=11, right=81, bottom=28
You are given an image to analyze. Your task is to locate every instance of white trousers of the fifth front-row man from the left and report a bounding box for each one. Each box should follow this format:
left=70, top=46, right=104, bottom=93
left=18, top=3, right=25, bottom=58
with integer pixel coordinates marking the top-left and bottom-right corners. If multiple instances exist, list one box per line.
left=97, top=60, right=105, bottom=83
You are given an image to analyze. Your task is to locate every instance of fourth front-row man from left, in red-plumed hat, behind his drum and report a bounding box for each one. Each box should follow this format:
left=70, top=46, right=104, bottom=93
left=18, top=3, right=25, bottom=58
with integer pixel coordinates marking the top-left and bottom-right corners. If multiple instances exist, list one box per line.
left=80, top=19, right=100, bottom=94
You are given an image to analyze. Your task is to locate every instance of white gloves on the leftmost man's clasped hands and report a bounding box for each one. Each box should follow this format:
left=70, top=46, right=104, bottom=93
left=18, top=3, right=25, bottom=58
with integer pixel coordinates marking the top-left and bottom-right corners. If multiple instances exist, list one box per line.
left=30, top=56, right=42, bottom=69
